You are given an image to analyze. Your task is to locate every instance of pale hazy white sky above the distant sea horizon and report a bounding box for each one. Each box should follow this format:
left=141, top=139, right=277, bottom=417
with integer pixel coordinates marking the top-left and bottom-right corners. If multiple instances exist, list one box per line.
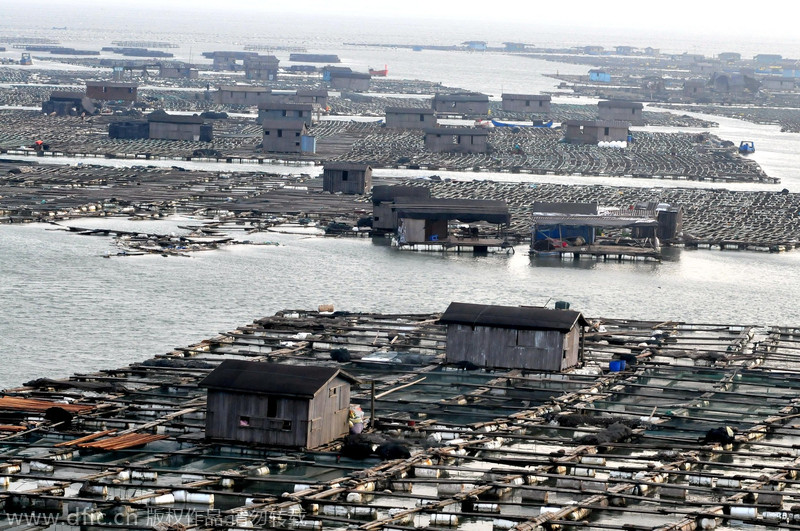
left=28, top=0, right=796, bottom=39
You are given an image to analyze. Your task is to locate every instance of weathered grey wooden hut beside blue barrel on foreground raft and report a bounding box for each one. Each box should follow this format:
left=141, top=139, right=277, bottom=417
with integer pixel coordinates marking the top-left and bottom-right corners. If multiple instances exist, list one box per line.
left=439, top=302, right=588, bottom=372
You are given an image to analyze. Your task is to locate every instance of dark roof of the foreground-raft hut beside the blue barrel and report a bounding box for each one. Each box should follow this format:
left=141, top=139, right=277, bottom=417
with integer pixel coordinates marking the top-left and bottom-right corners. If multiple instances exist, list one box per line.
left=439, top=302, right=588, bottom=332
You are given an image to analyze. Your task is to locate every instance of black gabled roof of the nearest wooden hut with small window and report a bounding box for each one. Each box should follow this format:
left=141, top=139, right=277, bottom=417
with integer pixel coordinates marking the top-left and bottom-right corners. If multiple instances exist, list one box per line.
left=198, top=360, right=358, bottom=398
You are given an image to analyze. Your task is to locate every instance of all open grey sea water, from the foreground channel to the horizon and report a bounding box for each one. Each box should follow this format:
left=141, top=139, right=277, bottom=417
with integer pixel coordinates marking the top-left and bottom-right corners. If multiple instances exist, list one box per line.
left=0, top=7, right=800, bottom=388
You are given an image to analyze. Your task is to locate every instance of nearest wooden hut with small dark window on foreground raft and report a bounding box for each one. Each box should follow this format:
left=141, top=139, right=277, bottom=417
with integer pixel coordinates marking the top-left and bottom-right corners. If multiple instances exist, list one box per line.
left=199, top=360, right=358, bottom=448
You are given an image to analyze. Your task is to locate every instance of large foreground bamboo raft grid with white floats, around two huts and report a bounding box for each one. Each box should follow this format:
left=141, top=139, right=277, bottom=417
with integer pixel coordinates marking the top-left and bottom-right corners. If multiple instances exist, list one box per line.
left=0, top=311, right=800, bottom=531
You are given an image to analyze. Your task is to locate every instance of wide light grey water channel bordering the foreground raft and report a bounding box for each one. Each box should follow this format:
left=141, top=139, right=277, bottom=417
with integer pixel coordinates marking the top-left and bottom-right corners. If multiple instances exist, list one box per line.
left=0, top=214, right=800, bottom=388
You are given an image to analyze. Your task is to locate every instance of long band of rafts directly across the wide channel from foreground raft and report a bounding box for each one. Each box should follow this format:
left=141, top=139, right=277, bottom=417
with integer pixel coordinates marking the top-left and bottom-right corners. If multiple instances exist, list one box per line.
left=0, top=162, right=800, bottom=252
